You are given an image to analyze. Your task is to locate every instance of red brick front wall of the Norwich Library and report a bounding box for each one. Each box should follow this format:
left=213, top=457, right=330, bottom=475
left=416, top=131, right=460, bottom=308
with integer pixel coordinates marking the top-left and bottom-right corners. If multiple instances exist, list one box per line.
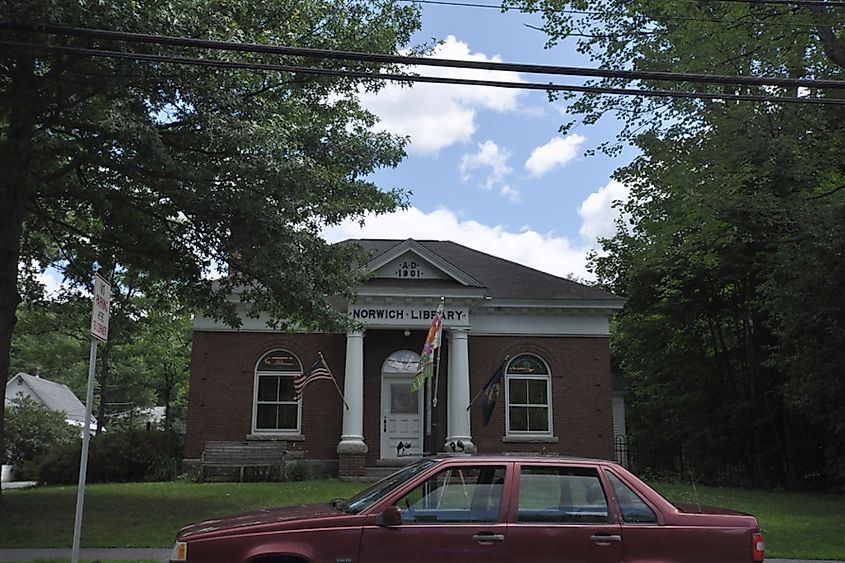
left=185, top=330, right=613, bottom=465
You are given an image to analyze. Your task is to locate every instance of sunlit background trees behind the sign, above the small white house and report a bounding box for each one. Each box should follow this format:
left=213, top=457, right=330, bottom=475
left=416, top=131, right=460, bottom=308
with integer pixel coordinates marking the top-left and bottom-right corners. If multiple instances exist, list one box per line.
left=12, top=286, right=192, bottom=427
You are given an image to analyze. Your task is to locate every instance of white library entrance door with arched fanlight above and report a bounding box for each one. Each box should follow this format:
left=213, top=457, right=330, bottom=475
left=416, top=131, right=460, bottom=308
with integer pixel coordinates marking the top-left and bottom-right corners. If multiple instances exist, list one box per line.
left=381, top=350, right=423, bottom=459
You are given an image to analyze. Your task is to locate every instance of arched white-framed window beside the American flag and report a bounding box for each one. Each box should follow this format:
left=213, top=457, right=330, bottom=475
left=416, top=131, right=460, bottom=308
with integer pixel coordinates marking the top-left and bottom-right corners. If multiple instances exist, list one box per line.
left=252, top=350, right=302, bottom=433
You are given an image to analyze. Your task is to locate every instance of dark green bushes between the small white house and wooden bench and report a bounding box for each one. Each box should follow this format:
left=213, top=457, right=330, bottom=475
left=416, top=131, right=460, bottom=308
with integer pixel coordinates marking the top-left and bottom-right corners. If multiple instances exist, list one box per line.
left=37, top=430, right=182, bottom=485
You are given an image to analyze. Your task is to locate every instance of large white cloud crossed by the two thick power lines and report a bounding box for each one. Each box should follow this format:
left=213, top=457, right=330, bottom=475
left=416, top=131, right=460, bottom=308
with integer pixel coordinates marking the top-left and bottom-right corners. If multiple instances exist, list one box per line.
left=360, top=35, right=523, bottom=154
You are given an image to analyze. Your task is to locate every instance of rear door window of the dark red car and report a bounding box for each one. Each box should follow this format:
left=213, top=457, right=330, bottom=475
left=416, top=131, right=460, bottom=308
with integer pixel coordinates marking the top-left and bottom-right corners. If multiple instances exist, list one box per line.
left=517, top=465, right=609, bottom=524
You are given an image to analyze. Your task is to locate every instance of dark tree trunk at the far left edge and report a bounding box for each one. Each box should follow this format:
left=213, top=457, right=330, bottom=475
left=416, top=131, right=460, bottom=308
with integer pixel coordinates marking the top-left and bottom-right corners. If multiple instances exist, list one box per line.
left=0, top=54, right=35, bottom=502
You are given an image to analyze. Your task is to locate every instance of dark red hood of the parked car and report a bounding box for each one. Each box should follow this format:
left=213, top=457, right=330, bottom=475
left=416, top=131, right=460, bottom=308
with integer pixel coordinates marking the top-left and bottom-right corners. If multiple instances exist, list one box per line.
left=179, top=504, right=350, bottom=540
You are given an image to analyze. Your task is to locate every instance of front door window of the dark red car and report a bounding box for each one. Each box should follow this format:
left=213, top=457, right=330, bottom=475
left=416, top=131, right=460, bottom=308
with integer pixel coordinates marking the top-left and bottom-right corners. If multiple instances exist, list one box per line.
left=396, top=466, right=505, bottom=524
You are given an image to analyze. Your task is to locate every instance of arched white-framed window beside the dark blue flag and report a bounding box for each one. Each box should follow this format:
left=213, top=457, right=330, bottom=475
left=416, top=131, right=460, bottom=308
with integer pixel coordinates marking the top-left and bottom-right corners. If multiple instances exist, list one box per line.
left=505, top=354, right=552, bottom=436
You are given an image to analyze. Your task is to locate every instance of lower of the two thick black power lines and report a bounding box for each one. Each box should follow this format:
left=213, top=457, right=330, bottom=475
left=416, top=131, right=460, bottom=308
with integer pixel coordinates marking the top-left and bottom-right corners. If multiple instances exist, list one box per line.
left=6, top=41, right=845, bottom=105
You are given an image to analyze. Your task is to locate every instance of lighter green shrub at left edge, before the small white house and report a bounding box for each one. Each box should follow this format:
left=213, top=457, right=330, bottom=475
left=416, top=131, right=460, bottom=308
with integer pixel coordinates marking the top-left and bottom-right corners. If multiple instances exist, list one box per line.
left=5, top=396, right=80, bottom=479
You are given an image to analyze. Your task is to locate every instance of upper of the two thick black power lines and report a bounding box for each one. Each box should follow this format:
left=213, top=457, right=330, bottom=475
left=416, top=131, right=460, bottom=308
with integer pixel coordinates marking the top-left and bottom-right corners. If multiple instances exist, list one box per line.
left=6, top=22, right=845, bottom=89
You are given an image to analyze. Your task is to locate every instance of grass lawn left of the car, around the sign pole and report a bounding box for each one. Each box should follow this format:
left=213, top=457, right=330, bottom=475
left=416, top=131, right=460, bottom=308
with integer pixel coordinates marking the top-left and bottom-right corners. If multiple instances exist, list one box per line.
left=0, top=480, right=363, bottom=548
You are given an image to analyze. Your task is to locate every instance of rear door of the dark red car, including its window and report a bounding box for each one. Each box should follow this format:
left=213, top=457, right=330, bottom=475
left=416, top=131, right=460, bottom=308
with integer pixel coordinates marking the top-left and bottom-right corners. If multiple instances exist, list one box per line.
left=507, top=463, right=623, bottom=563
